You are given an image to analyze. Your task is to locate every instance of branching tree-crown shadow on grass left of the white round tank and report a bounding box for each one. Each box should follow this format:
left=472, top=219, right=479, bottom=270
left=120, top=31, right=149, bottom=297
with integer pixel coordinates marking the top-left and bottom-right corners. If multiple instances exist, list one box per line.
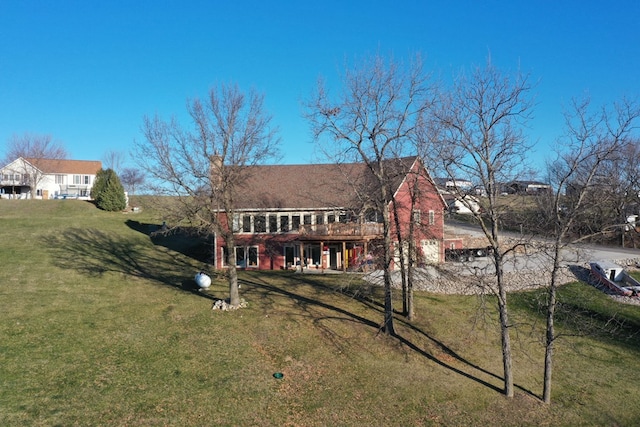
left=42, top=228, right=218, bottom=300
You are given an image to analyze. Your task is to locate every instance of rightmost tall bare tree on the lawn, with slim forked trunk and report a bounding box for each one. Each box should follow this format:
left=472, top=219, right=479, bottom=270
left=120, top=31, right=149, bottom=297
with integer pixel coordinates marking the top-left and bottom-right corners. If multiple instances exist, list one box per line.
left=541, top=96, right=640, bottom=403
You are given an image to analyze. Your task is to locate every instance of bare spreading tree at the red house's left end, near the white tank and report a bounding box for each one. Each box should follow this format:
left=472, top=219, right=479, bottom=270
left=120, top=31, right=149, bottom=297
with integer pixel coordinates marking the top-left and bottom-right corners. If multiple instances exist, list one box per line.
left=135, top=85, right=278, bottom=307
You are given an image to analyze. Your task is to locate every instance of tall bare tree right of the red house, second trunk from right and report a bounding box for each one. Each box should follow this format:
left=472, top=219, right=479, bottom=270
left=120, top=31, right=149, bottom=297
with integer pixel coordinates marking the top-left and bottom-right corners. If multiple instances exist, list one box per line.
left=422, top=61, right=532, bottom=397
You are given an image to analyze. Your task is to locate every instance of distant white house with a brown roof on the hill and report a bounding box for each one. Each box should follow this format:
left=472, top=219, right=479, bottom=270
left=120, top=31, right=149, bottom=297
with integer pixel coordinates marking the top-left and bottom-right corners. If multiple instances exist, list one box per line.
left=0, top=157, right=102, bottom=200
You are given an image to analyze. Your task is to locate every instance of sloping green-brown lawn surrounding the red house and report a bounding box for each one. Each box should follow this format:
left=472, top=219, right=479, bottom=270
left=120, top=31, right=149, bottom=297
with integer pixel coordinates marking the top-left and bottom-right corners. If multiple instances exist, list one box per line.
left=0, top=200, right=640, bottom=426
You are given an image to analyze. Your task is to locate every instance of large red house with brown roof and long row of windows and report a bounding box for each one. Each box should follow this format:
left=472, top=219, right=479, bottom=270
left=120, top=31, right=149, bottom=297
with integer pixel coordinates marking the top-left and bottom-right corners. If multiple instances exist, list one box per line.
left=214, top=157, right=445, bottom=270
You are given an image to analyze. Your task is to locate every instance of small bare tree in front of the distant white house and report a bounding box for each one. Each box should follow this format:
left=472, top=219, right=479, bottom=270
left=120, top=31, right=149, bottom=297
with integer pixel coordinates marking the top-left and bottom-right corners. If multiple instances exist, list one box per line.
left=6, top=132, right=67, bottom=198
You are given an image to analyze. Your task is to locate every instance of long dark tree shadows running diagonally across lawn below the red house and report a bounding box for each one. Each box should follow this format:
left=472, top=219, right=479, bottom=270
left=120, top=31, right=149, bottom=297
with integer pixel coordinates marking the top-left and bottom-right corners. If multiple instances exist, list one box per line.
left=239, top=275, right=516, bottom=396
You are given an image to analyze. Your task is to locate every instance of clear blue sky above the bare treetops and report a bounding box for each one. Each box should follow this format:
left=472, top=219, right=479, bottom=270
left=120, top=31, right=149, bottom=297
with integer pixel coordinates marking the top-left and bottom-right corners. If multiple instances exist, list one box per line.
left=0, top=0, right=640, bottom=174
